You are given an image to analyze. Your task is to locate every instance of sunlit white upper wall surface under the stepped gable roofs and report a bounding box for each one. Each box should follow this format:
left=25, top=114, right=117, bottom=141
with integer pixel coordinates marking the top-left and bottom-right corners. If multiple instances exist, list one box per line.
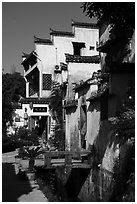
left=35, top=27, right=99, bottom=97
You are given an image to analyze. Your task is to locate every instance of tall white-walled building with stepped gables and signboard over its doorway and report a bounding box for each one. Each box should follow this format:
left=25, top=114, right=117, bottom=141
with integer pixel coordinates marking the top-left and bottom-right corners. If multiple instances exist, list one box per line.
left=15, top=21, right=100, bottom=143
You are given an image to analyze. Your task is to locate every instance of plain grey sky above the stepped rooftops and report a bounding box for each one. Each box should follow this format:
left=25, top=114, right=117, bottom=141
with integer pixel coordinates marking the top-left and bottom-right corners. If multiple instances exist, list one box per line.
left=2, top=2, right=95, bottom=75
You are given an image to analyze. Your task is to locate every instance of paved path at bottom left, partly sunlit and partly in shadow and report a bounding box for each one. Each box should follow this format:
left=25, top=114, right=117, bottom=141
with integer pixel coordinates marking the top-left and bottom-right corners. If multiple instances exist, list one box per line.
left=2, top=151, right=48, bottom=202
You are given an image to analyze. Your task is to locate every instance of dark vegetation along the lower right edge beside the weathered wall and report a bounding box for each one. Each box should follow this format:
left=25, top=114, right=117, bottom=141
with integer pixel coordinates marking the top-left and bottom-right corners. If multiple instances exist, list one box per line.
left=110, top=109, right=135, bottom=202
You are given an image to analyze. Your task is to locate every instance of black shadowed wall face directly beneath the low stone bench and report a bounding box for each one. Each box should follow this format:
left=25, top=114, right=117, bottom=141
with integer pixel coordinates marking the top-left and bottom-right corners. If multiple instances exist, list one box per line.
left=56, top=166, right=90, bottom=202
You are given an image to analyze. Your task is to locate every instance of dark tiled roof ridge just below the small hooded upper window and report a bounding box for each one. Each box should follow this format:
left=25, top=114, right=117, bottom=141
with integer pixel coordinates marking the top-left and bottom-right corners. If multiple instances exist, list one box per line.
left=65, top=54, right=100, bottom=64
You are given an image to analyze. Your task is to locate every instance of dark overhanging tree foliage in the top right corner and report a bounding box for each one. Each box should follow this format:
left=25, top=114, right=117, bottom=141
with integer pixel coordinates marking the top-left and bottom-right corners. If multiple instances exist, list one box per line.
left=81, top=2, right=135, bottom=37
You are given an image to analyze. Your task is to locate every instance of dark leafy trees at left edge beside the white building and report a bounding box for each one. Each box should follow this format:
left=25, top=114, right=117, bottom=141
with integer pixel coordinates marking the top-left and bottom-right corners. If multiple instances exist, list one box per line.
left=2, top=72, right=25, bottom=136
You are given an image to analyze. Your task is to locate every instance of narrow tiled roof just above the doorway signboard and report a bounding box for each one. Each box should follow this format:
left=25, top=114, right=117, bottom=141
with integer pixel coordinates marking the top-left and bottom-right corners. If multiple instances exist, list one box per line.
left=20, top=98, right=49, bottom=104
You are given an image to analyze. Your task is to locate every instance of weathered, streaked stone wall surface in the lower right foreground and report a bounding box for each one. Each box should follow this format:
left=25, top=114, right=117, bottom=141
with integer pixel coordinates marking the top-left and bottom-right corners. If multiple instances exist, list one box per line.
left=79, top=121, right=119, bottom=202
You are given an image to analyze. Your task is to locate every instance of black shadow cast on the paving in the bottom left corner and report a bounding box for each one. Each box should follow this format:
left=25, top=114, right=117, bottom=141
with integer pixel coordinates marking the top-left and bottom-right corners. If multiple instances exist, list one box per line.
left=2, top=163, right=32, bottom=202
